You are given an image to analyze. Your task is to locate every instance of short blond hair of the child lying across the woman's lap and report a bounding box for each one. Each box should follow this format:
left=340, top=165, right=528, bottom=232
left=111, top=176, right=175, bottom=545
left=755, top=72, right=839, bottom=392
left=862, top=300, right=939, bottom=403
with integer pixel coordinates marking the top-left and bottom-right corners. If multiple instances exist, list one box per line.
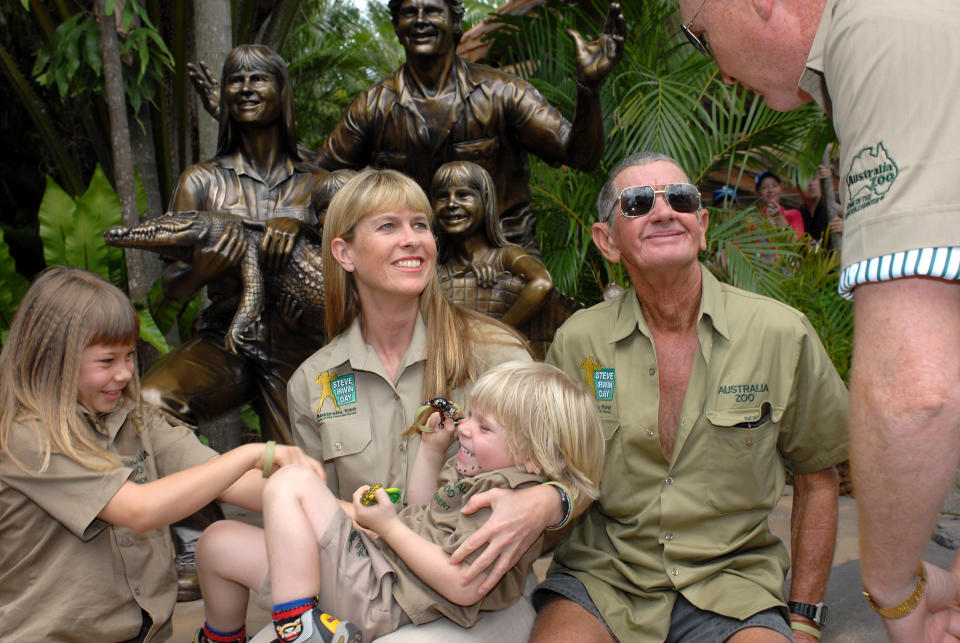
left=470, top=362, right=604, bottom=502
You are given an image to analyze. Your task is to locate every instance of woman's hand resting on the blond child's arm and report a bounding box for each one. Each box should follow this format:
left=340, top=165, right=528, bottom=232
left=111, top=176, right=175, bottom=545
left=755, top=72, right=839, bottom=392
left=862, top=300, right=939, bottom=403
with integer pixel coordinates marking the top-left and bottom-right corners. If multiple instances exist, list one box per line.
left=450, top=485, right=563, bottom=595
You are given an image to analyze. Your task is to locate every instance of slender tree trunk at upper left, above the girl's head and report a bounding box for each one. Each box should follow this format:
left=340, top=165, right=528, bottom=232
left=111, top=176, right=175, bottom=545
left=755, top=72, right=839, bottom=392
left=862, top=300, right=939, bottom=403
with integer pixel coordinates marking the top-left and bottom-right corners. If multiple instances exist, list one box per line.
left=95, top=0, right=150, bottom=300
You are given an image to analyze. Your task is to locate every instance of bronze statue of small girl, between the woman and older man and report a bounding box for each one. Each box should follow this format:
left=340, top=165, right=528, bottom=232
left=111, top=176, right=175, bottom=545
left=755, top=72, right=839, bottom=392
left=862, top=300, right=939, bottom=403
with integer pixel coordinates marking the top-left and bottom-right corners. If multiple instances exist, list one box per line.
left=430, top=161, right=553, bottom=327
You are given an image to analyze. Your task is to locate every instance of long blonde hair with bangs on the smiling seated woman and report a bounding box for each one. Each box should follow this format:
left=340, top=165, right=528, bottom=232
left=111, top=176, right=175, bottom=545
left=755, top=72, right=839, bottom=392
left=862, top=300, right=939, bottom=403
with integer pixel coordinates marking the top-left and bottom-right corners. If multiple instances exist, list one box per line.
left=323, top=168, right=526, bottom=406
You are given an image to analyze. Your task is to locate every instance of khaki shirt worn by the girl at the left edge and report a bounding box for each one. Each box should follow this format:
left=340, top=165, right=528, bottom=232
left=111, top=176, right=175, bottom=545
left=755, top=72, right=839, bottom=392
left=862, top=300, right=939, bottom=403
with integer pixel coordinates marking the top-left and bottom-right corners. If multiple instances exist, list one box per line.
left=0, top=403, right=216, bottom=643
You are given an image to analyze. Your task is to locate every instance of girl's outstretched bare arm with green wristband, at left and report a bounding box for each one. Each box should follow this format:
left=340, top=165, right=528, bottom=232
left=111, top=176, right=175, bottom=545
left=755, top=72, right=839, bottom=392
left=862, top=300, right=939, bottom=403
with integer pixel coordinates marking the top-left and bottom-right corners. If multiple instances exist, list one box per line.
left=98, top=444, right=323, bottom=531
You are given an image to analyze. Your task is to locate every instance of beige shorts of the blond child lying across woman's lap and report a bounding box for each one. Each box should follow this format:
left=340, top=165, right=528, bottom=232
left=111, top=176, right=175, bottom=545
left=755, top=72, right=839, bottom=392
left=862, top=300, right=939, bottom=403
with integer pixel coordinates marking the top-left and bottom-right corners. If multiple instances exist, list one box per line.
left=258, top=510, right=410, bottom=641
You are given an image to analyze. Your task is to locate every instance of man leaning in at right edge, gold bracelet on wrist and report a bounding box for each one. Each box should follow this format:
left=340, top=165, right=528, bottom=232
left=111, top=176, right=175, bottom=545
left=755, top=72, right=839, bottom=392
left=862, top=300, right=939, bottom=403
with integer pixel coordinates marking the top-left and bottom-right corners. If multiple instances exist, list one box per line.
left=680, top=0, right=960, bottom=643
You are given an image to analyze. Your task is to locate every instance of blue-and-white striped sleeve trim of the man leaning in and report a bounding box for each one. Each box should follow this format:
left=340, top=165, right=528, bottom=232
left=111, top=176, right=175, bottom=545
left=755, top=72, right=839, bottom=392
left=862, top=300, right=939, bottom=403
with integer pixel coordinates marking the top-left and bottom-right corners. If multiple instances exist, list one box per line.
left=838, top=246, right=960, bottom=300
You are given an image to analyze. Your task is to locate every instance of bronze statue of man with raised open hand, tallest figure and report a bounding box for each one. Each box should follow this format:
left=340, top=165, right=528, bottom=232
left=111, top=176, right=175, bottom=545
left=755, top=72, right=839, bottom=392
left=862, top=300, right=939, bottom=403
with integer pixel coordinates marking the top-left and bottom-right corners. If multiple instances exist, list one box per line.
left=317, top=0, right=626, bottom=248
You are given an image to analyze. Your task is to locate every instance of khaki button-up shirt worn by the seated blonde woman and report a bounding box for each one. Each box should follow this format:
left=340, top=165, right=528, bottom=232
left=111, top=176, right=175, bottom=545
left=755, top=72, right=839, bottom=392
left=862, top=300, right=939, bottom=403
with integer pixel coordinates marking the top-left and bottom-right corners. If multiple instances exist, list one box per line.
left=287, top=315, right=531, bottom=500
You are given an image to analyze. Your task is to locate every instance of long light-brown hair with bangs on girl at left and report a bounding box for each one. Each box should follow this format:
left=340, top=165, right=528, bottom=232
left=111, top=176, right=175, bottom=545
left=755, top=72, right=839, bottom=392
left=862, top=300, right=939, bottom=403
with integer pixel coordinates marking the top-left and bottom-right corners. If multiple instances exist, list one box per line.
left=0, top=266, right=140, bottom=472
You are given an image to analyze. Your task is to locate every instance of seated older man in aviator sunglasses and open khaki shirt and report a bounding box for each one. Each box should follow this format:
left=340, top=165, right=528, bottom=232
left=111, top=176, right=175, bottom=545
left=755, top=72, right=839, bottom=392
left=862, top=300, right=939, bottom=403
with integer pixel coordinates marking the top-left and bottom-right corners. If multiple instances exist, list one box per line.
left=531, top=153, right=847, bottom=643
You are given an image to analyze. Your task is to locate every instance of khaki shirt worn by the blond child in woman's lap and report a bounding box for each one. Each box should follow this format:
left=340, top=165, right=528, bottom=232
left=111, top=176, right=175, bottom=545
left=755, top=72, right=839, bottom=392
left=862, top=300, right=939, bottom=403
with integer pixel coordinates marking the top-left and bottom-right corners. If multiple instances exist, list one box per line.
left=376, top=456, right=546, bottom=627
